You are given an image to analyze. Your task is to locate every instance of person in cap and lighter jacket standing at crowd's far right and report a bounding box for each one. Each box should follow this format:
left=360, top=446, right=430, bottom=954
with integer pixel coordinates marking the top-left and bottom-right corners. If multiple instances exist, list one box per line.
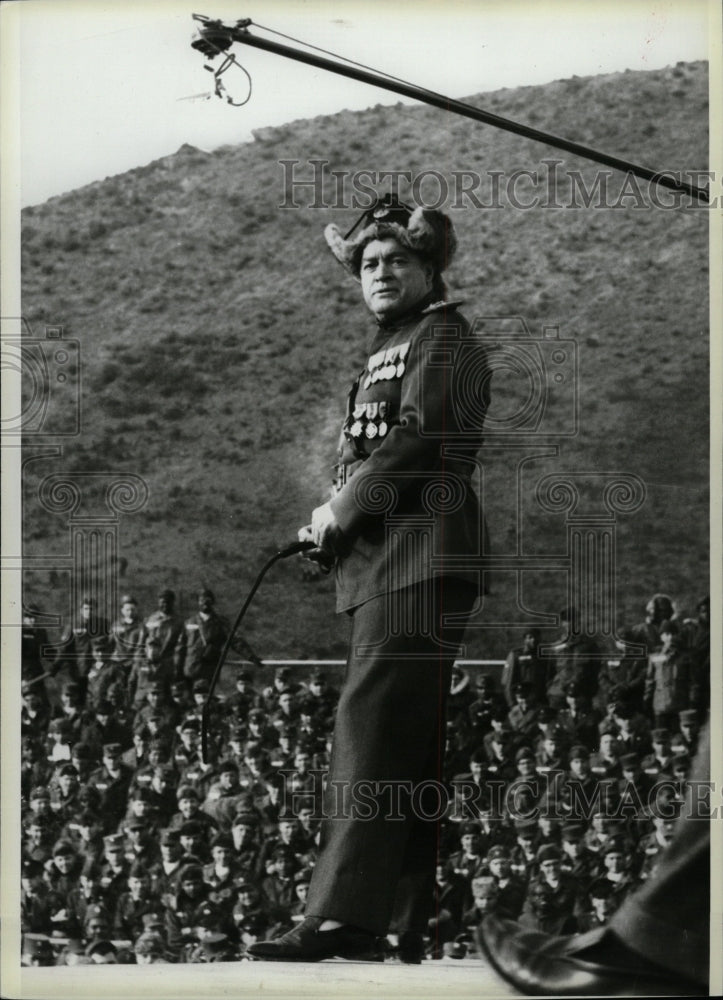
left=644, top=620, right=693, bottom=729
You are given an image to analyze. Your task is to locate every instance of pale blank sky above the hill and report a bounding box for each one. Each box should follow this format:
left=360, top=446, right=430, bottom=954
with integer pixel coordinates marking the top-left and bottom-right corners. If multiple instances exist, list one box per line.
left=0, top=0, right=710, bottom=205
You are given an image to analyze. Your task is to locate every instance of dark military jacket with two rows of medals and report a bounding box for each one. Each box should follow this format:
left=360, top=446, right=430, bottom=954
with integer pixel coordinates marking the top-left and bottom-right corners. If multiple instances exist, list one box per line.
left=331, top=302, right=489, bottom=611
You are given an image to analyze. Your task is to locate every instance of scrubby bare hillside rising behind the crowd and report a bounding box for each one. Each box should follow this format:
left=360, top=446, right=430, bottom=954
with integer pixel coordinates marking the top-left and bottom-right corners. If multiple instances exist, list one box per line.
left=22, top=63, right=708, bottom=658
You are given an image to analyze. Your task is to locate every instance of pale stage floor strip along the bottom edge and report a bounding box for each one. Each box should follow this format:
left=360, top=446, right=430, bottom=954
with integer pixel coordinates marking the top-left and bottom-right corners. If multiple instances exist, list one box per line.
left=3, top=958, right=520, bottom=1000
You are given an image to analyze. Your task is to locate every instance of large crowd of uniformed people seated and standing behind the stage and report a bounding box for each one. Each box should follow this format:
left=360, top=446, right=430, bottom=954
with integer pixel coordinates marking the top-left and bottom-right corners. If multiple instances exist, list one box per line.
left=21, top=589, right=709, bottom=965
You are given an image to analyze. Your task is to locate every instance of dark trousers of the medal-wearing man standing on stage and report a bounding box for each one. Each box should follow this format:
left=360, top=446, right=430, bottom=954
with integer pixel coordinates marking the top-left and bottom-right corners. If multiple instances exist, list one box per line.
left=306, top=578, right=477, bottom=934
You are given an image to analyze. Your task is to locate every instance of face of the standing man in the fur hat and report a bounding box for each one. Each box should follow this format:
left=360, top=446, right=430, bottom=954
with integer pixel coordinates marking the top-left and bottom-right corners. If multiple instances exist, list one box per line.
left=359, top=238, right=432, bottom=319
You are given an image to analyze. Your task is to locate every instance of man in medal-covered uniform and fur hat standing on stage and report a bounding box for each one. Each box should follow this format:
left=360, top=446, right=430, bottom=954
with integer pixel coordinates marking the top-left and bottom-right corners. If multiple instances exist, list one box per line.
left=249, top=196, right=489, bottom=962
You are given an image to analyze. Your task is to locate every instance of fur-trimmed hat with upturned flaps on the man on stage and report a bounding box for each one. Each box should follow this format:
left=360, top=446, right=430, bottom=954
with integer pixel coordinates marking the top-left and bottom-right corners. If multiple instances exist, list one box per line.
left=324, top=194, right=457, bottom=279
